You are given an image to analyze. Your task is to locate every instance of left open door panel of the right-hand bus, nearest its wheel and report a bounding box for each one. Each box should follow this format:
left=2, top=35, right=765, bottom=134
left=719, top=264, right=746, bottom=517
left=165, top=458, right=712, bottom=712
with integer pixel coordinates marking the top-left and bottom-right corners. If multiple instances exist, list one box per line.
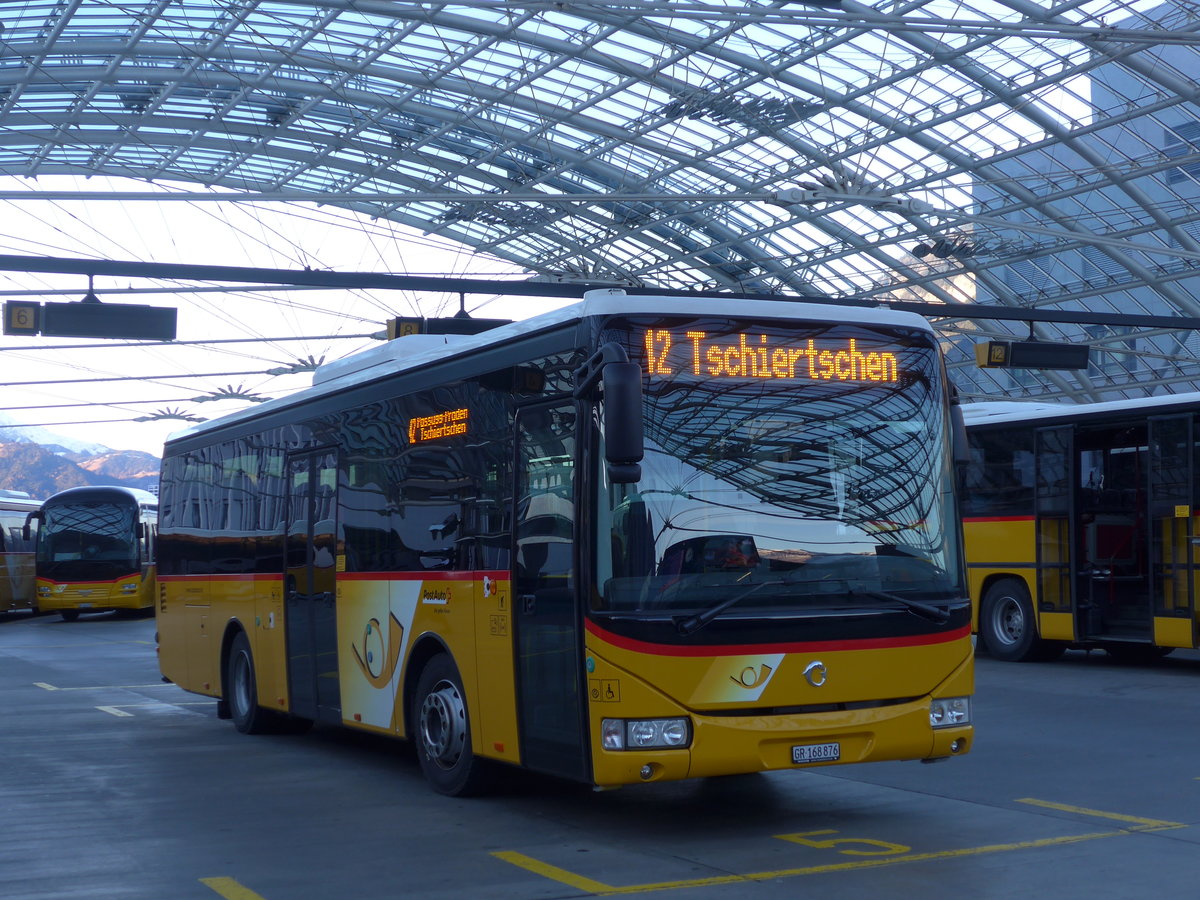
left=1034, top=425, right=1087, bottom=641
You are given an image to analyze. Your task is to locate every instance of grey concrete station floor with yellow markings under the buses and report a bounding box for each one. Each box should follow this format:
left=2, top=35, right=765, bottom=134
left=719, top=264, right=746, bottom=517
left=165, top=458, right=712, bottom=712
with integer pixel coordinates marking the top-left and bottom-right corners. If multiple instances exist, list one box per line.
left=0, top=614, right=1200, bottom=900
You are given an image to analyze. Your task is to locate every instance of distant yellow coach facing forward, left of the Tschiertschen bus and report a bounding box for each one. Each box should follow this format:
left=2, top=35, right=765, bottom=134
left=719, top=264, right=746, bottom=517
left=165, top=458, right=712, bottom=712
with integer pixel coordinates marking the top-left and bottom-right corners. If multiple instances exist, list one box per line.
left=31, top=485, right=158, bottom=622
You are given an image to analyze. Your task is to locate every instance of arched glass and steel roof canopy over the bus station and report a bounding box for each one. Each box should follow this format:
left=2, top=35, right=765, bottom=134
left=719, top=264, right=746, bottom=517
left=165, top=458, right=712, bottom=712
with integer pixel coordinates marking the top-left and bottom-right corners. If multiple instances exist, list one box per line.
left=0, top=0, right=1200, bottom=400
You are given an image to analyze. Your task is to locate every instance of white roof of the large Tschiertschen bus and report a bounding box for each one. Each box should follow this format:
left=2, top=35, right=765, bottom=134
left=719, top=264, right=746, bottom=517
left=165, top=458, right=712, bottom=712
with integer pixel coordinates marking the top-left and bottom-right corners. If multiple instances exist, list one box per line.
left=168, top=288, right=932, bottom=443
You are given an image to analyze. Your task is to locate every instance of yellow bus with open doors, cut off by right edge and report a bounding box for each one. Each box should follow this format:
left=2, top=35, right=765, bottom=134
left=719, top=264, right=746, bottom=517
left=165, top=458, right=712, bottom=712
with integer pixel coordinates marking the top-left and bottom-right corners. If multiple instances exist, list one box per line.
left=962, top=394, right=1200, bottom=661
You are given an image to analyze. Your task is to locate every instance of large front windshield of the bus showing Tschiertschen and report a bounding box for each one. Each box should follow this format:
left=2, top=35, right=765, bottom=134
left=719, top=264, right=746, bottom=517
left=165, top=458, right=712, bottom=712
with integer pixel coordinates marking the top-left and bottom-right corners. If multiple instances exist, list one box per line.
left=593, top=320, right=964, bottom=630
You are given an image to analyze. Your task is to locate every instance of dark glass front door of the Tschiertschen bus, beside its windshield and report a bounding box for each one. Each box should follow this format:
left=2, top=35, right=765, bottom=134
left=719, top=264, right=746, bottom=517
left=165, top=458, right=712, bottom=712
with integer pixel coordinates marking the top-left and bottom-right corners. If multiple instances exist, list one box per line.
left=512, top=402, right=592, bottom=781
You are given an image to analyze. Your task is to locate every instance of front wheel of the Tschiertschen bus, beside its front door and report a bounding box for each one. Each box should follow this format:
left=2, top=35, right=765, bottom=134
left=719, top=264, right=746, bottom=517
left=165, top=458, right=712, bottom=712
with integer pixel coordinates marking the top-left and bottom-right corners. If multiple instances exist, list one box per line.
left=413, top=653, right=487, bottom=797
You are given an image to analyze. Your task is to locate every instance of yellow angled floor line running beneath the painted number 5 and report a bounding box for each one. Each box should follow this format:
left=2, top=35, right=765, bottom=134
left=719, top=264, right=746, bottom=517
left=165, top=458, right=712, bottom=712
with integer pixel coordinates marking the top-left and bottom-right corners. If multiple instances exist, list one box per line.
left=492, top=829, right=1130, bottom=895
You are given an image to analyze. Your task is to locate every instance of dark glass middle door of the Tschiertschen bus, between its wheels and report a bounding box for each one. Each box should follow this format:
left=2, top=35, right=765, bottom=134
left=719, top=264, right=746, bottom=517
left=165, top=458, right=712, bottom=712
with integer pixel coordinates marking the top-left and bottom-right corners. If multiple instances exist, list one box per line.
left=283, top=450, right=342, bottom=722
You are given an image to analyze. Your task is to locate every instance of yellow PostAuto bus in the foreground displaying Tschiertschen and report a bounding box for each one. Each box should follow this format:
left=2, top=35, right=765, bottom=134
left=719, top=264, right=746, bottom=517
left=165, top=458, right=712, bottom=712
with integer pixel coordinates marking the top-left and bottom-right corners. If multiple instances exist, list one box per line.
left=157, top=290, right=973, bottom=794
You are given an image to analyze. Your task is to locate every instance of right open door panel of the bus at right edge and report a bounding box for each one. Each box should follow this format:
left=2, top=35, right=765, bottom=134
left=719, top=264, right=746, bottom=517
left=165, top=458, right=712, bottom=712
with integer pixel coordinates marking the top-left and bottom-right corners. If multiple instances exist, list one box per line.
left=1147, top=415, right=1195, bottom=647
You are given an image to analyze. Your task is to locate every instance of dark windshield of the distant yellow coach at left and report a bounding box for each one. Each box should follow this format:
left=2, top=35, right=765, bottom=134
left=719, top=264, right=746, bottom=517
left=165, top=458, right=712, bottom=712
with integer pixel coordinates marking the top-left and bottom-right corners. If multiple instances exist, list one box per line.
left=37, top=502, right=138, bottom=578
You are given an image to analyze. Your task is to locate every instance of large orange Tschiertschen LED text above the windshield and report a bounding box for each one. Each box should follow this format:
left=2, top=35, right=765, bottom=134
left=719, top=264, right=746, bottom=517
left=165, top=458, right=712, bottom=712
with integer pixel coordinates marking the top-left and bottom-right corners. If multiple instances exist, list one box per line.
left=646, top=329, right=900, bottom=382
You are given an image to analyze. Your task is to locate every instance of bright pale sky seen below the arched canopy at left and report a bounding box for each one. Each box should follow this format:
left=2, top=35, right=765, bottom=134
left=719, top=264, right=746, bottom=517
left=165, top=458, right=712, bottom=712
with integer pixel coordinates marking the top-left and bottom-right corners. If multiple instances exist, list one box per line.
left=0, top=176, right=570, bottom=456
